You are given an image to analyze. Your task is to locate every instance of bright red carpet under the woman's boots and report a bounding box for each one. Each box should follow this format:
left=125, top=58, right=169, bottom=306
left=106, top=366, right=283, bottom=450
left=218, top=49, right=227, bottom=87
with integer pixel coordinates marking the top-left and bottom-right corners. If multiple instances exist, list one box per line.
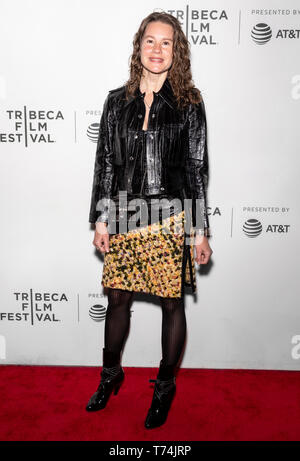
left=0, top=365, right=300, bottom=441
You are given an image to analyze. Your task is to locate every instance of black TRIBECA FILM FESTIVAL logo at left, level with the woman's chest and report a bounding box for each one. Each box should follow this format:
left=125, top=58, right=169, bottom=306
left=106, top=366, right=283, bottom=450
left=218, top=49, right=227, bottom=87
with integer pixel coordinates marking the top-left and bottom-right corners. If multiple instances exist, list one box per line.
left=0, top=106, right=64, bottom=147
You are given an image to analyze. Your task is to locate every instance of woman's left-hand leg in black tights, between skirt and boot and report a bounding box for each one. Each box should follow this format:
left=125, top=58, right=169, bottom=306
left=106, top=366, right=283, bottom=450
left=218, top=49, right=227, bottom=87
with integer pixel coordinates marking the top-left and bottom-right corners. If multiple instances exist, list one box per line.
left=104, top=288, right=134, bottom=353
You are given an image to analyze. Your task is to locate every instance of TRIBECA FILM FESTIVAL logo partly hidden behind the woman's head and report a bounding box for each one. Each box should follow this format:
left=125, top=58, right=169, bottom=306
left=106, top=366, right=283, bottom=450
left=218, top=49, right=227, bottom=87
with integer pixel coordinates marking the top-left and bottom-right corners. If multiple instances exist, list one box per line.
left=162, top=5, right=228, bottom=45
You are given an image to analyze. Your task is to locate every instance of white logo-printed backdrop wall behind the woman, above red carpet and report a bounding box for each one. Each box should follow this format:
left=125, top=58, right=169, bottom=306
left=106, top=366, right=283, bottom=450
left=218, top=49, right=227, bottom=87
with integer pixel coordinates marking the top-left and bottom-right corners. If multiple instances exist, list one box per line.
left=0, top=0, right=300, bottom=370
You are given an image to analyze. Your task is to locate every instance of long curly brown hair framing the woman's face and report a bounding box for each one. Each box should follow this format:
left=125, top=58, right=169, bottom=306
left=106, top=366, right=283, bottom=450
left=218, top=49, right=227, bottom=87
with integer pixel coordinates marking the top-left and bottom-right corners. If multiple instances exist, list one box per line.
left=125, top=12, right=202, bottom=108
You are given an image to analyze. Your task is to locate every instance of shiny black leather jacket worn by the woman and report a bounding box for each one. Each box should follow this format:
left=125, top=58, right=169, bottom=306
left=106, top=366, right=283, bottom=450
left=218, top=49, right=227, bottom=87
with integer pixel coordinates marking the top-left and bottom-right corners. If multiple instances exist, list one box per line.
left=89, top=78, right=210, bottom=235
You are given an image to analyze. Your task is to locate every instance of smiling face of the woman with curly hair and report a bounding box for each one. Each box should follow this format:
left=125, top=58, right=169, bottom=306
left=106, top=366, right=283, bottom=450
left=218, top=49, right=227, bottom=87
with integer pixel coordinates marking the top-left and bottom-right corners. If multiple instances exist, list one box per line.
left=141, top=21, right=174, bottom=74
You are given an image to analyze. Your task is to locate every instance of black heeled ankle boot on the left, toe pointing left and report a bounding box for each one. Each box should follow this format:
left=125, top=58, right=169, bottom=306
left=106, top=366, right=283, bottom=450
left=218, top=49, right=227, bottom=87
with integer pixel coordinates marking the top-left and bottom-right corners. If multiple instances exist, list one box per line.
left=86, top=348, right=125, bottom=411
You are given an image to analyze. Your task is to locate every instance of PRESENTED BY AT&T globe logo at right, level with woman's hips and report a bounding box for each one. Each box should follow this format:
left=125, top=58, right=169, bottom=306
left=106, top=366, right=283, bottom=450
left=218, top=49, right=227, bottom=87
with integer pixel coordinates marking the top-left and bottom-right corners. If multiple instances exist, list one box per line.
left=243, top=207, right=291, bottom=238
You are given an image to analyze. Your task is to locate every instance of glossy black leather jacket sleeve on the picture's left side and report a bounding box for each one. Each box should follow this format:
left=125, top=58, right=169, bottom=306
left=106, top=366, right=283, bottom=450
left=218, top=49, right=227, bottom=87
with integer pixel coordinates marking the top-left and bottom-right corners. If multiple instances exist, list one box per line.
left=89, top=94, right=114, bottom=223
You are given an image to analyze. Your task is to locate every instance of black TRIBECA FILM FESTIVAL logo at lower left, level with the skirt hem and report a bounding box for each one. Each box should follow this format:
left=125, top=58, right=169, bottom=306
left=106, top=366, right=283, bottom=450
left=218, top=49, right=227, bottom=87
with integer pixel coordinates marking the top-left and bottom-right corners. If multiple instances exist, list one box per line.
left=0, top=289, right=68, bottom=325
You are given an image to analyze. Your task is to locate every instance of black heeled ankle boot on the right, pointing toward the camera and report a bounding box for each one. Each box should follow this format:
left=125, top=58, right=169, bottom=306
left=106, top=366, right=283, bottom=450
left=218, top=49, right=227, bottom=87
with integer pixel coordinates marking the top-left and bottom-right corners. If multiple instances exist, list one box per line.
left=145, top=365, right=176, bottom=429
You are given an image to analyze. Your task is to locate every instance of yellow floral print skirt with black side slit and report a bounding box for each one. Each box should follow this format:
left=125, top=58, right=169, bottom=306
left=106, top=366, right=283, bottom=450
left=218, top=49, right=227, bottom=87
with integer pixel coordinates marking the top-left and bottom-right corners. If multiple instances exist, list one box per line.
left=101, top=211, right=196, bottom=298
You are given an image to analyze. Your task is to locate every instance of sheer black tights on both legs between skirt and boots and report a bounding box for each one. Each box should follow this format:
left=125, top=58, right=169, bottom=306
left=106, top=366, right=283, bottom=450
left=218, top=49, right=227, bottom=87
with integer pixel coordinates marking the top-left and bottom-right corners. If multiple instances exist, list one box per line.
left=104, top=288, right=186, bottom=366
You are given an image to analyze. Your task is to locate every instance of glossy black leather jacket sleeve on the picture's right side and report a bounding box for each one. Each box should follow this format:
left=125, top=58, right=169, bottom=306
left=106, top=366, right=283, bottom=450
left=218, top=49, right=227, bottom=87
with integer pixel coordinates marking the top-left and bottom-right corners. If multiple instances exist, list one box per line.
left=185, top=100, right=211, bottom=236
